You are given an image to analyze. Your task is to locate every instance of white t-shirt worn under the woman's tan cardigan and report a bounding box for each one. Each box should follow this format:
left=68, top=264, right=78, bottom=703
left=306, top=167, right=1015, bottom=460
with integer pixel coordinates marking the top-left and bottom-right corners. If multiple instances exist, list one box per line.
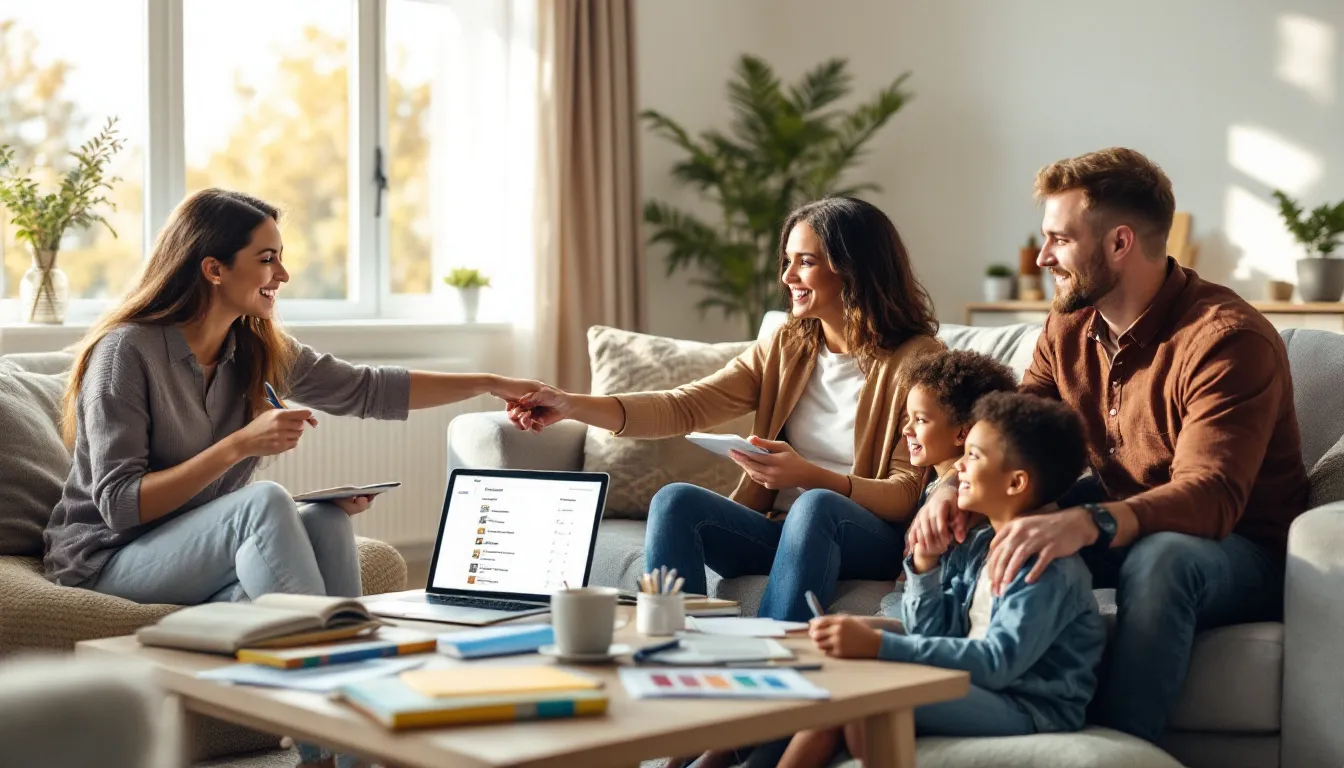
left=774, top=343, right=864, bottom=511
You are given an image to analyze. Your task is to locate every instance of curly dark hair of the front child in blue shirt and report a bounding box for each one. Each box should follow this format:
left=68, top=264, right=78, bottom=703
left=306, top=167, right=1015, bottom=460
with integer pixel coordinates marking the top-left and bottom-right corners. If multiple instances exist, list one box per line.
left=974, top=391, right=1087, bottom=507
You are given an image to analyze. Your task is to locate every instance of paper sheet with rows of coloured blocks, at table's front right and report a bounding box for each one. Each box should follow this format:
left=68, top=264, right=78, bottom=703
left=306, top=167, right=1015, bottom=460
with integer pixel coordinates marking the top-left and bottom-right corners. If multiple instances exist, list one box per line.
left=620, top=667, right=831, bottom=699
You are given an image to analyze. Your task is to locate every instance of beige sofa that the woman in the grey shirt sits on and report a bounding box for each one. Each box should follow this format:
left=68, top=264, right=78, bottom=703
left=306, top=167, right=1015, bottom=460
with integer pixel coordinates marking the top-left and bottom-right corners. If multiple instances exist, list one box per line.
left=0, top=354, right=406, bottom=757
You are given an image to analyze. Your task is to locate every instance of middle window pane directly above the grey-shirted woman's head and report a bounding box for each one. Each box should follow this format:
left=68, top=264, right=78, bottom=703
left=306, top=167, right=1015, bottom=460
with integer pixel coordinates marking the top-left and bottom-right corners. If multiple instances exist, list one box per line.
left=183, top=0, right=355, bottom=300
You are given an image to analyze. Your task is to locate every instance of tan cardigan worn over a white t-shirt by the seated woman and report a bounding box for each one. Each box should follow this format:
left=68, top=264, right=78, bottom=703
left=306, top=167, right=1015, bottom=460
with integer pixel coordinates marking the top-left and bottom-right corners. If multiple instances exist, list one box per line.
left=614, top=331, right=942, bottom=521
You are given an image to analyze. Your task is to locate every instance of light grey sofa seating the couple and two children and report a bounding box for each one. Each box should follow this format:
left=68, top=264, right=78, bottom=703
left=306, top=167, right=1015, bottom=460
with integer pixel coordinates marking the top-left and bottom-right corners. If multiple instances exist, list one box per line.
left=449, top=313, right=1344, bottom=768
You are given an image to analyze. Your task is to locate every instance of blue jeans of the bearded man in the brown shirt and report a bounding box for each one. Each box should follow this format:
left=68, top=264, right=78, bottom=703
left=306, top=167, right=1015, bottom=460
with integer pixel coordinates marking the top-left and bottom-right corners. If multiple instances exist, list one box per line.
left=1060, top=483, right=1284, bottom=741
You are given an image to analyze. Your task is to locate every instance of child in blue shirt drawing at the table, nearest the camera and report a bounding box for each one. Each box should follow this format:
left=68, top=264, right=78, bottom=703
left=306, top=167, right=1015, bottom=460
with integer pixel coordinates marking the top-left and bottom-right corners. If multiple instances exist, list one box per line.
left=780, top=393, right=1106, bottom=768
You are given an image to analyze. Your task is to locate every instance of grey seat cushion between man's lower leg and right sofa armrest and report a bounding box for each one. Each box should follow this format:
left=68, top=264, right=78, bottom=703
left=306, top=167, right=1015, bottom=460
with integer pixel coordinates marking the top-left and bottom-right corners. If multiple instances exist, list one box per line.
left=1169, top=621, right=1284, bottom=734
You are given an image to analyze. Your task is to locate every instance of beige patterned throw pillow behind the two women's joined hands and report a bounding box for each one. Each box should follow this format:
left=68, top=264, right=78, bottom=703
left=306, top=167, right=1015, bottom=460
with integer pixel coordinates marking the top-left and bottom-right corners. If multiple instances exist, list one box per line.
left=583, top=325, right=754, bottom=519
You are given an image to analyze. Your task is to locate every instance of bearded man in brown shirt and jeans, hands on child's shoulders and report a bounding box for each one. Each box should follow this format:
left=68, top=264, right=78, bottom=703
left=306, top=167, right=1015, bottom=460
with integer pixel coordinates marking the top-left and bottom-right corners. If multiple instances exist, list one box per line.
left=914, top=149, right=1308, bottom=741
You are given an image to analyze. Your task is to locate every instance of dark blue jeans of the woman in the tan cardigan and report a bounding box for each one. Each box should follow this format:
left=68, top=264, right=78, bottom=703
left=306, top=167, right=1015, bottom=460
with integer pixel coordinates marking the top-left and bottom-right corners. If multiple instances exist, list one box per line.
left=644, top=483, right=906, bottom=621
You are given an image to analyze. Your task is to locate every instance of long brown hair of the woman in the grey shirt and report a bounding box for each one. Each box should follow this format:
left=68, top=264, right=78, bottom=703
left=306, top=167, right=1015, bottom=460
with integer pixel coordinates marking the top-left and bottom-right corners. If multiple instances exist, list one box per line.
left=60, top=190, right=296, bottom=447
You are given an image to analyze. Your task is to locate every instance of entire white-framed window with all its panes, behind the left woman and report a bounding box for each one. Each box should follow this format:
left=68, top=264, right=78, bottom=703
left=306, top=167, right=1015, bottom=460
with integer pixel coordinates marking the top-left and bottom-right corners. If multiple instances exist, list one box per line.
left=0, top=0, right=538, bottom=321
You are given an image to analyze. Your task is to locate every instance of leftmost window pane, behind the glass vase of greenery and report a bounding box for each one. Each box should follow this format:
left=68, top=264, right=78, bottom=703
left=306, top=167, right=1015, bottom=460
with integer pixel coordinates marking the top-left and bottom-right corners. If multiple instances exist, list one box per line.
left=0, top=0, right=146, bottom=299
